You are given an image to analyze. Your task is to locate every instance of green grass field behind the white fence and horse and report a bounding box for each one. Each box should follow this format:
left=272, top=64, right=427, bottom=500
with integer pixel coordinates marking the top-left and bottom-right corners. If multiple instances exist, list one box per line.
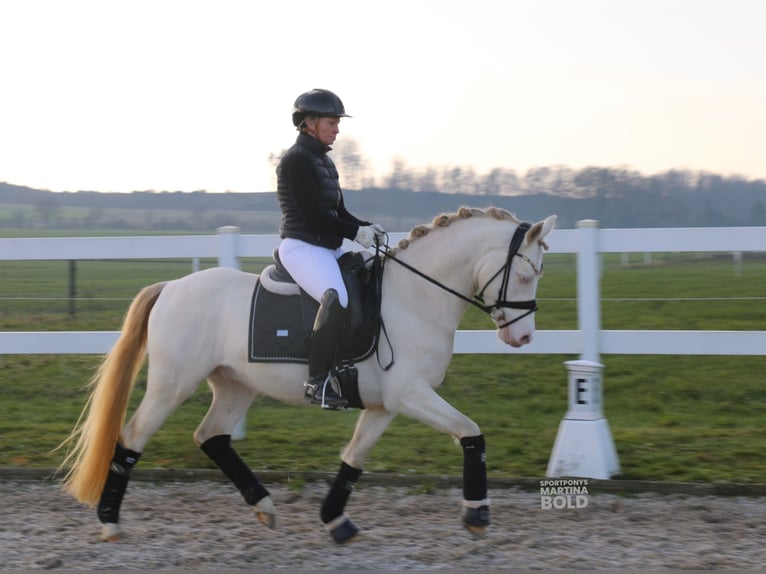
left=0, top=250, right=766, bottom=482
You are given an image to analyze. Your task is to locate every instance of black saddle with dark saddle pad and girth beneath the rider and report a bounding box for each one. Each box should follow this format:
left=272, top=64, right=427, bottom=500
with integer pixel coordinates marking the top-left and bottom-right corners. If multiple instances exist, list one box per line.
left=248, top=249, right=381, bottom=408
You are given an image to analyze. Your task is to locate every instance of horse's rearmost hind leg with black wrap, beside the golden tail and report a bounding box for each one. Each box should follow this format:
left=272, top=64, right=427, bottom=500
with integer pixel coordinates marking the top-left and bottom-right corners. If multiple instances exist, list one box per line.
left=97, top=366, right=202, bottom=542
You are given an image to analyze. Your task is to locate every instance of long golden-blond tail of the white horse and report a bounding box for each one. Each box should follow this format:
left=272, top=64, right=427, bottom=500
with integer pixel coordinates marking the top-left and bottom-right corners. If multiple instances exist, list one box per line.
left=60, top=282, right=167, bottom=506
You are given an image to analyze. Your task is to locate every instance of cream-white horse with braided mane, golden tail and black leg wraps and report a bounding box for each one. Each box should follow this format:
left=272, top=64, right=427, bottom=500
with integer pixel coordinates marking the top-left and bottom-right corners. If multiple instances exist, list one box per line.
left=60, top=207, right=556, bottom=544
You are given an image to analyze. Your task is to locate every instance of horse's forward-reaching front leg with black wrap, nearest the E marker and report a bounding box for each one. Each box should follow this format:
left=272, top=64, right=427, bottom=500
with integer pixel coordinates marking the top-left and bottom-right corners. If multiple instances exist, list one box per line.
left=401, top=388, right=490, bottom=537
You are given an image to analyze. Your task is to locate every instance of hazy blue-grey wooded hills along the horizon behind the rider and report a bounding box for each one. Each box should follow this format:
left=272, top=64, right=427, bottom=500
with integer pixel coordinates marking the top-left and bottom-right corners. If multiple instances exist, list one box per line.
left=0, top=168, right=766, bottom=233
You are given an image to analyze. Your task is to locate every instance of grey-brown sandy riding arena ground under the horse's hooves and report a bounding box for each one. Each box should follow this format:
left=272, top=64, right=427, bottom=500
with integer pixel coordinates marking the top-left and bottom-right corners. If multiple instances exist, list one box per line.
left=0, top=481, right=766, bottom=571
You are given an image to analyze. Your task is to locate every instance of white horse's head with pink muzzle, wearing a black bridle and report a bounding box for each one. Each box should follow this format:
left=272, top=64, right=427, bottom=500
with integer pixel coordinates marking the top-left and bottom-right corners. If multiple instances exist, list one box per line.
left=477, top=215, right=556, bottom=347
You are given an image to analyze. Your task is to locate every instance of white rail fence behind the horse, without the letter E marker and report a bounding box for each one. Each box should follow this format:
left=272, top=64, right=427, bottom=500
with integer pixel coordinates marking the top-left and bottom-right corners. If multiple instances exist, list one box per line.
left=0, top=220, right=766, bottom=362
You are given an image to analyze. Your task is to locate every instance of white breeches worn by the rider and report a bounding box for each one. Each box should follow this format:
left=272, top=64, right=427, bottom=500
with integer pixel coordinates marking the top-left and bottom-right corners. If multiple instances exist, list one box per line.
left=279, top=237, right=348, bottom=309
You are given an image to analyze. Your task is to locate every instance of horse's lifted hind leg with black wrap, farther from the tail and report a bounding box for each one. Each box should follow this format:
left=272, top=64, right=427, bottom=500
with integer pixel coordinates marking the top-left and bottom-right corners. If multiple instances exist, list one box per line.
left=194, top=369, right=276, bottom=528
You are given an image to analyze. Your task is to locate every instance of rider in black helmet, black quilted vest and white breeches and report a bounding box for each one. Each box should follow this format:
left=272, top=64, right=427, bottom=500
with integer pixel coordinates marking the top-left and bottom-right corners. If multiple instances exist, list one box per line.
left=277, top=90, right=384, bottom=409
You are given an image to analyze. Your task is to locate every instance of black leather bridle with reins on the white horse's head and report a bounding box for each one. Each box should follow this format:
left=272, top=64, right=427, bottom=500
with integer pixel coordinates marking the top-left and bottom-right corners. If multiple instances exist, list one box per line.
left=378, top=223, right=543, bottom=329
